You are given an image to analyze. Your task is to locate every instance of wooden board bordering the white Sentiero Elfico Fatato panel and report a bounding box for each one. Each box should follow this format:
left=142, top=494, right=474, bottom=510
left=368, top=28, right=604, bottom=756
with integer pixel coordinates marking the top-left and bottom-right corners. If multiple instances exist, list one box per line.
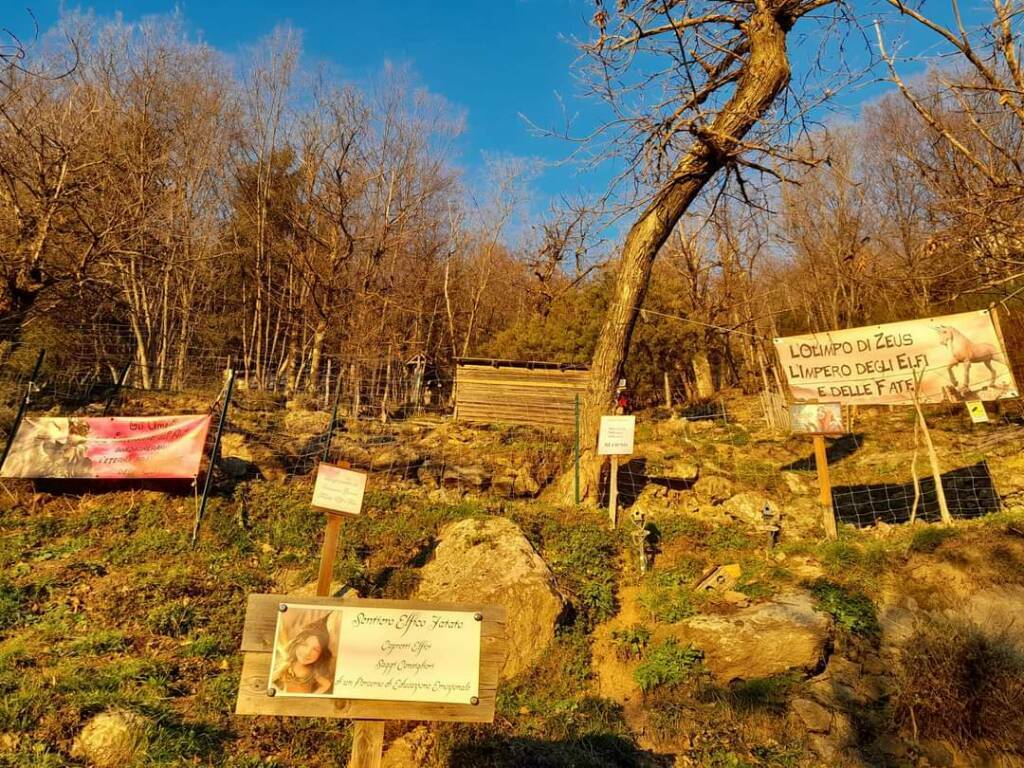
left=234, top=594, right=508, bottom=723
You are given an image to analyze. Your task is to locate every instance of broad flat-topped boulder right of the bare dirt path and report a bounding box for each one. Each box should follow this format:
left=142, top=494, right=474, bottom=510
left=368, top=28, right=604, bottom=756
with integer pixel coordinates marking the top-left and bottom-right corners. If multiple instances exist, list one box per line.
left=669, top=592, right=830, bottom=682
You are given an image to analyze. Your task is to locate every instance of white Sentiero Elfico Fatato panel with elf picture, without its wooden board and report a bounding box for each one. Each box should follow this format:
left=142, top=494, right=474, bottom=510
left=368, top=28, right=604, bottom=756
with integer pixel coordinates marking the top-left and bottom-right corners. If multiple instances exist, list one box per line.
left=270, top=603, right=482, bottom=703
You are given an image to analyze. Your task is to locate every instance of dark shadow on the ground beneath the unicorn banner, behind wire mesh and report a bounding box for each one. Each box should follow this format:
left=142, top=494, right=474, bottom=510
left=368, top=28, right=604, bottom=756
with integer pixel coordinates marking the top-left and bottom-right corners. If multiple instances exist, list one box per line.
left=833, top=461, right=1000, bottom=527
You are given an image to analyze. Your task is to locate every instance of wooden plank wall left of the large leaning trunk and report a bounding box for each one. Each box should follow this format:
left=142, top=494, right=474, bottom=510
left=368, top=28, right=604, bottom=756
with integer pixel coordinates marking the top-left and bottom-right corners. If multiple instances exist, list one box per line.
left=455, top=364, right=590, bottom=428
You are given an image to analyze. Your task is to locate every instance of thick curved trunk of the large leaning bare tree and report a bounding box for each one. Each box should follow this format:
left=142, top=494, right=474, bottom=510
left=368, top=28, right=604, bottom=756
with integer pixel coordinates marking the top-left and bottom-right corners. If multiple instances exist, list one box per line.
left=561, top=12, right=791, bottom=502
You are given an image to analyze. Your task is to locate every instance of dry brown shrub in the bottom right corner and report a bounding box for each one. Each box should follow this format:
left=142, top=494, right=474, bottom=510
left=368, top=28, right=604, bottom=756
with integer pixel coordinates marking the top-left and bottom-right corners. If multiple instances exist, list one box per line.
left=893, top=620, right=1024, bottom=754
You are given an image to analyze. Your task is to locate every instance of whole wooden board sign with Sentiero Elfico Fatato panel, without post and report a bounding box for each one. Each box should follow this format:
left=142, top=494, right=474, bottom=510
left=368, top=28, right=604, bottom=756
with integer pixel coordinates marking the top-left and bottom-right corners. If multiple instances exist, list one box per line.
left=234, top=594, right=506, bottom=723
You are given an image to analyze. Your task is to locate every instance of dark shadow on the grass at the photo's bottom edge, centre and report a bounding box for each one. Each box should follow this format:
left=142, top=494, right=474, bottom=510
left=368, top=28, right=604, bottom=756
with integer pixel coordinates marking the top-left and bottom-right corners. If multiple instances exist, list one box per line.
left=449, top=734, right=675, bottom=768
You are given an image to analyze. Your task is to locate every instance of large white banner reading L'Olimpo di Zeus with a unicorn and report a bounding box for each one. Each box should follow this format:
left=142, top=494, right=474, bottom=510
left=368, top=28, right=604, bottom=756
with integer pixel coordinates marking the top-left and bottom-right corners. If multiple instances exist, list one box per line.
left=774, top=309, right=1018, bottom=404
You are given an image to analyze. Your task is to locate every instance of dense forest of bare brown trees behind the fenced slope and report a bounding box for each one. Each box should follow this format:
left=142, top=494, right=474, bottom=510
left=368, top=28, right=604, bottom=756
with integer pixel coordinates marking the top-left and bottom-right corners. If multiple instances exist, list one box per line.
left=0, top=0, right=1024, bottom=411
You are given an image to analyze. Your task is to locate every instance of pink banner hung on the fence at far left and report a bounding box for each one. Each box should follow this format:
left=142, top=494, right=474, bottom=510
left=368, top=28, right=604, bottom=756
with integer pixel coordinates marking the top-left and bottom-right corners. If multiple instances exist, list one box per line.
left=0, top=416, right=210, bottom=479
